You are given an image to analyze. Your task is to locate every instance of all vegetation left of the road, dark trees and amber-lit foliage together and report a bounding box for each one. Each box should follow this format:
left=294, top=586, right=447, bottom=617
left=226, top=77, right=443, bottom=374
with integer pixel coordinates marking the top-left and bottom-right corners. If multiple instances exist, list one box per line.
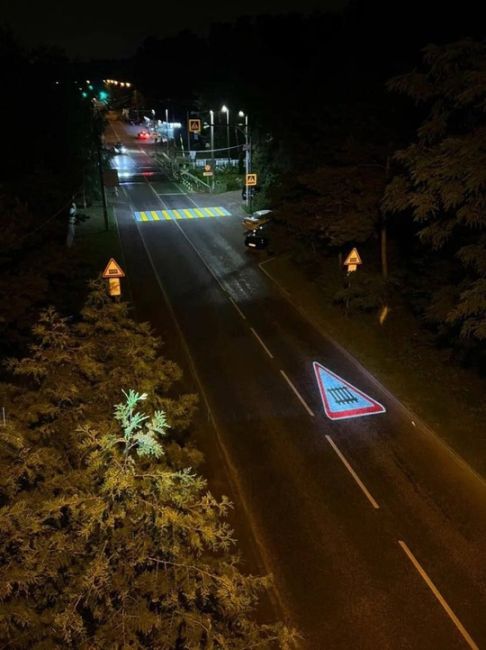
left=0, top=30, right=296, bottom=650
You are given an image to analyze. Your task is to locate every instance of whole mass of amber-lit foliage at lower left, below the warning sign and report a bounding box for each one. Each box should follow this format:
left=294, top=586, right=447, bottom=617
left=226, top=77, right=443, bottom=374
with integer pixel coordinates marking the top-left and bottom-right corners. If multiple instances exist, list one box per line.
left=0, top=284, right=293, bottom=650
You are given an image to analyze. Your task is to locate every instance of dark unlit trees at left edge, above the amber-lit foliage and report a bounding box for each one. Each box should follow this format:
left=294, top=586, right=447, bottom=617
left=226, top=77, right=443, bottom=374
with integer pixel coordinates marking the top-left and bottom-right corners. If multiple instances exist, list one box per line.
left=0, top=29, right=101, bottom=355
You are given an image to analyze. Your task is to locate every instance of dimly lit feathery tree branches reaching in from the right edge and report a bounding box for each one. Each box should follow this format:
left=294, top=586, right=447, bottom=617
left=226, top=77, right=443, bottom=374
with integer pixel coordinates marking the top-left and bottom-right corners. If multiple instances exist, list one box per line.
left=383, top=40, right=486, bottom=350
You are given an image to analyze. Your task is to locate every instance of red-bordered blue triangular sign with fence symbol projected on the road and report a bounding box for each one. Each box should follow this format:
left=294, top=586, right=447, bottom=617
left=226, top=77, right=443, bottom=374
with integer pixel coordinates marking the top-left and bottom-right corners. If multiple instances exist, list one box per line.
left=314, top=361, right=386, bottom=420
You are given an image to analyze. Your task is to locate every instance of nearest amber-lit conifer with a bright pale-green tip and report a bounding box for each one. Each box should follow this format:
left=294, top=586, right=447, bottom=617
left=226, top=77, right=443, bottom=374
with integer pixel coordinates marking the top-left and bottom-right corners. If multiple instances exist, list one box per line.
left=0, top=390, right=295, bottom=650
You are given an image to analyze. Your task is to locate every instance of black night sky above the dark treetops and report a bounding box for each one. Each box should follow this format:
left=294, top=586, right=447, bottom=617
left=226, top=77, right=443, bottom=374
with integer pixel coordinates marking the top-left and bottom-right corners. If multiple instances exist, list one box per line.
left=2, top=0, right=346, bottom=58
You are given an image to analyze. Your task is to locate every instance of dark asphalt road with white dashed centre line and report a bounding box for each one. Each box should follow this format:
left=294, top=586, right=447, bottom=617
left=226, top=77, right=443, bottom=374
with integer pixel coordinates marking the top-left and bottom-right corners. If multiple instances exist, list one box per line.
left=104, top=123, right=486, bottom=650
